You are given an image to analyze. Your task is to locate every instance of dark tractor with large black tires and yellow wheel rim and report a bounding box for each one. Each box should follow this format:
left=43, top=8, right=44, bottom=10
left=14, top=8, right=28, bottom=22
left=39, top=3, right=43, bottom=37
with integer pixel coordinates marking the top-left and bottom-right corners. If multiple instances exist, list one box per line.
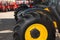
left=13, top=0, right=60, bottom=40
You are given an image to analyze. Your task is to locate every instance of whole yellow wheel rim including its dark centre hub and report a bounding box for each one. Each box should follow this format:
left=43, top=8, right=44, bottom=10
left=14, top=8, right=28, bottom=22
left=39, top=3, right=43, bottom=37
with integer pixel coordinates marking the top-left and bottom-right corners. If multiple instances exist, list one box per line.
left=25, top=23, right=48, bottom=40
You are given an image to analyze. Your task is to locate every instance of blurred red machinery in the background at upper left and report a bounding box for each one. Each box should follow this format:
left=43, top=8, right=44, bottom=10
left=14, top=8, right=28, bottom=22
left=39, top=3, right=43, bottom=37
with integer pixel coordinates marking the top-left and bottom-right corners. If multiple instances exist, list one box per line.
left=0, top=2, right=18, bottom=12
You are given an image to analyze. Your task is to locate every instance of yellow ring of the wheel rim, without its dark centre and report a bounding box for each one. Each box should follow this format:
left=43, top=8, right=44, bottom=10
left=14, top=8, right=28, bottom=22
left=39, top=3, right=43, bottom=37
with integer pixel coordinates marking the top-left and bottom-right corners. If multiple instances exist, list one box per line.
left=25, top=23, right=48, bottom=40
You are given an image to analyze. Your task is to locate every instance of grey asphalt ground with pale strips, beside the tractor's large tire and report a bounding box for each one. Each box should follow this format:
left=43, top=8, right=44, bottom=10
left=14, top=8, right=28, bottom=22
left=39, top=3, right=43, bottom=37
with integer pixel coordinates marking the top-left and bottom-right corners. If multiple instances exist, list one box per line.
left=0, top=12, right=60, bottom=40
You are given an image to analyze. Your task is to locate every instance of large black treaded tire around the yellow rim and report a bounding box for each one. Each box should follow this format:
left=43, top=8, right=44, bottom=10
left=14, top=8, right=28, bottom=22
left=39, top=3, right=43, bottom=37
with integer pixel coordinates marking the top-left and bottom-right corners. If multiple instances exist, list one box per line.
left=13, top=9, right=55, bottom=40
